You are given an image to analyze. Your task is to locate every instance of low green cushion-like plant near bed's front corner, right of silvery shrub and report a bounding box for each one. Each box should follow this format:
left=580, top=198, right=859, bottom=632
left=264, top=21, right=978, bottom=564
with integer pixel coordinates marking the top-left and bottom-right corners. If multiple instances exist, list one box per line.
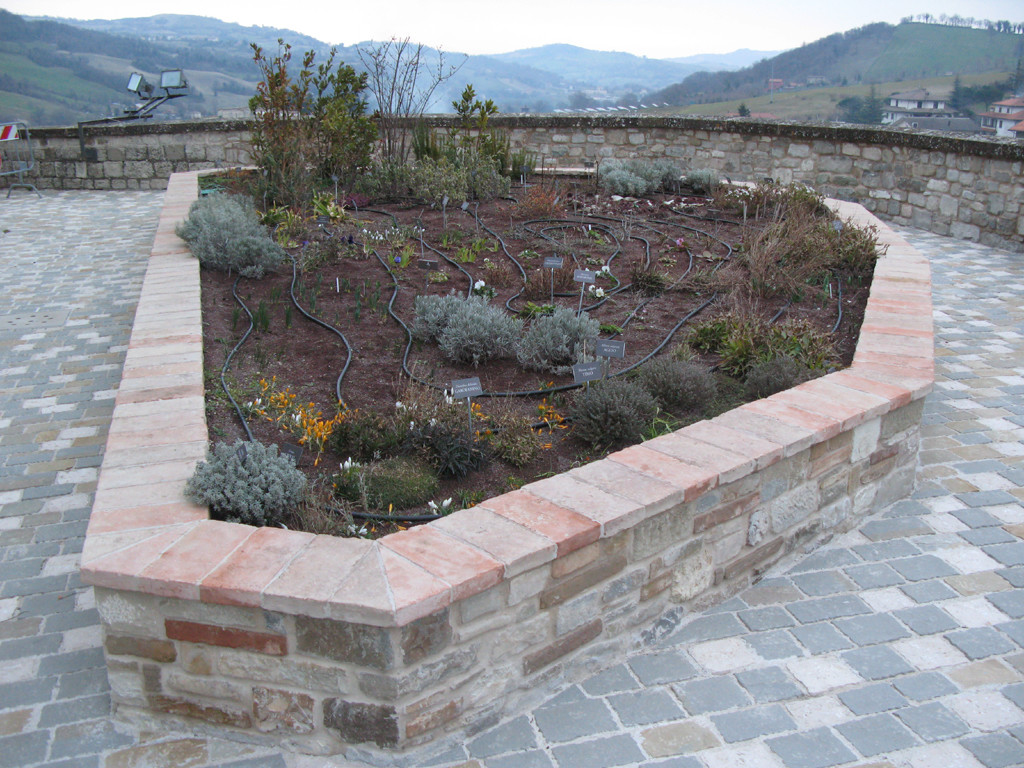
left=334, top=457, right=439, bottom=512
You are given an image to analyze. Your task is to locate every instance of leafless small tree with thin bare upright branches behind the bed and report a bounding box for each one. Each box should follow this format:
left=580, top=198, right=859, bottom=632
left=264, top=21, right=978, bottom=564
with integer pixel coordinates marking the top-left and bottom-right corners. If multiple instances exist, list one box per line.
left=358, top=38, right=462, bottom=163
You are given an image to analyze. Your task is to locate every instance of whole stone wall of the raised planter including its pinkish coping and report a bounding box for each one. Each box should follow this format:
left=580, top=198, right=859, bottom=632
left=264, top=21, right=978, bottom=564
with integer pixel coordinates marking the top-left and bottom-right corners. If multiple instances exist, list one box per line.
left=82, top=172, right=933, bottom=754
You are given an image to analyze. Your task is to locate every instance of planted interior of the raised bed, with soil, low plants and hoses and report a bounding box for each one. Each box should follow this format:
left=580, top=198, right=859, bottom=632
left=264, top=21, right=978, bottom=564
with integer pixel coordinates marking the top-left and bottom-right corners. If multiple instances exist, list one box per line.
left=195, top=176, right=873, bottom=535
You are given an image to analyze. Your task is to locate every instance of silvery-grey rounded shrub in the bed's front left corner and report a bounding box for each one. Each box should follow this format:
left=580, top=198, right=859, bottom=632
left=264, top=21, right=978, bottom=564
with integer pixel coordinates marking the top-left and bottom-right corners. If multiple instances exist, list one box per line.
left=185, top=440, right=306, bottom=526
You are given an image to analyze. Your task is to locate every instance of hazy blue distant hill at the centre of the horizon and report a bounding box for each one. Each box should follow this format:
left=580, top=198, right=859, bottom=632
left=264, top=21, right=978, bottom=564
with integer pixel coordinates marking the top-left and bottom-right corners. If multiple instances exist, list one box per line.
left=492, top=43, right=702, bottom=92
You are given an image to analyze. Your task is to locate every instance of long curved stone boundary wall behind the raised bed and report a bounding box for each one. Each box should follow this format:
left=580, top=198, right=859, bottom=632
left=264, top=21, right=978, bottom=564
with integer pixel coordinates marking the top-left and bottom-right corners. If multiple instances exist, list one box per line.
left=9, top=116, right=1024, bottom=251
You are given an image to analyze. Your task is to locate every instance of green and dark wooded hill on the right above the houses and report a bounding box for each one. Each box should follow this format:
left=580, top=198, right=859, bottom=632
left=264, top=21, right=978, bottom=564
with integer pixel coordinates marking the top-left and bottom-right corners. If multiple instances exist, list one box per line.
left=650, top=22, right=1024, bottom=105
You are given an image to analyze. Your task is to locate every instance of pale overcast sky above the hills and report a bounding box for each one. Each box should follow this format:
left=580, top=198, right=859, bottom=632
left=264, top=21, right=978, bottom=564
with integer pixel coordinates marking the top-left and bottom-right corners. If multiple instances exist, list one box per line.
left=8, top=0, right=1024, bottom=58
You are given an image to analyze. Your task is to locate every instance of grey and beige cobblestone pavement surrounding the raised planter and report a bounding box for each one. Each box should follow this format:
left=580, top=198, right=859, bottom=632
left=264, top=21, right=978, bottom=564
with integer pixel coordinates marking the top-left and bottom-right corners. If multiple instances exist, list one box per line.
left=0, top=193, right=1024, bottom=768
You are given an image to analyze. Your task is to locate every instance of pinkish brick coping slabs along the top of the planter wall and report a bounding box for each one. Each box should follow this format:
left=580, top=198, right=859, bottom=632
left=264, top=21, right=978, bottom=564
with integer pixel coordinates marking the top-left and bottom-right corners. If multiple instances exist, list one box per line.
left=82, top=172, right=934, bottom=627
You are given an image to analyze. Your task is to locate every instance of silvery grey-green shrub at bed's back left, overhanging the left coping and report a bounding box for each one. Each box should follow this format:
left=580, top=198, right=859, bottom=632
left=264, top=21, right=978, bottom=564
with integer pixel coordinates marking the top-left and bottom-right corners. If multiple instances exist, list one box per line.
left=175, top=195, right=285, bottom=278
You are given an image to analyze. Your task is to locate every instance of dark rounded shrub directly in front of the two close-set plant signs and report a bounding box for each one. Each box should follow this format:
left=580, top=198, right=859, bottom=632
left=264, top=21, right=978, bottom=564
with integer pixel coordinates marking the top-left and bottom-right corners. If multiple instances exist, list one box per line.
left=568, top=379, right=657, bottom=447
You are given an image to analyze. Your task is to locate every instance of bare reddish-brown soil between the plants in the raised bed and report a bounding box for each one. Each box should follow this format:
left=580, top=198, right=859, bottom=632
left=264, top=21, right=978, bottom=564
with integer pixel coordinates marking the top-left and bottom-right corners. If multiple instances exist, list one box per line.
left=202, top=182, right=868, bottom=532
